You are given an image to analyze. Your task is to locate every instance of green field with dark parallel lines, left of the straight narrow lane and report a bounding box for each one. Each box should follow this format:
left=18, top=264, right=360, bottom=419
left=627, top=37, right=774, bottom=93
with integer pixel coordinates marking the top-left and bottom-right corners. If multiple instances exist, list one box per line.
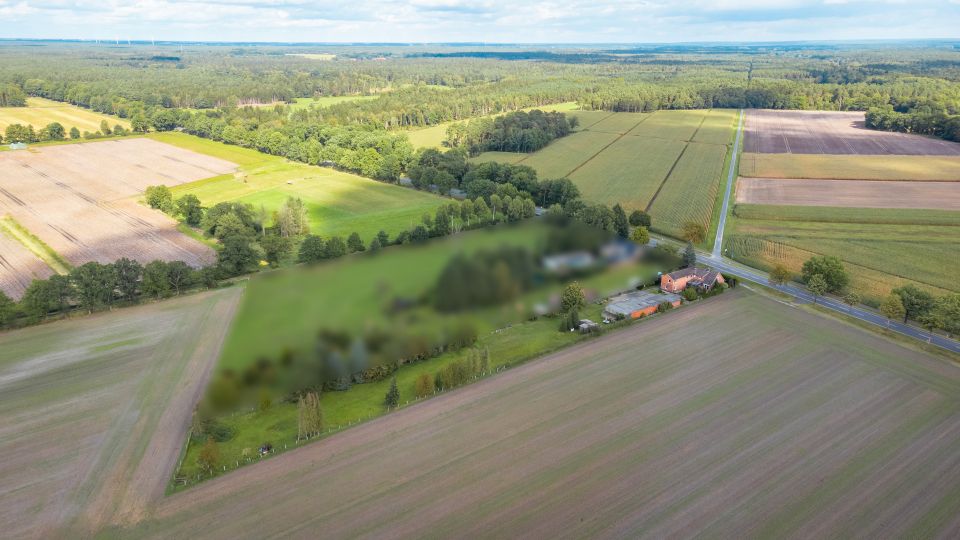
left=474, top=109, right=737, bottom=236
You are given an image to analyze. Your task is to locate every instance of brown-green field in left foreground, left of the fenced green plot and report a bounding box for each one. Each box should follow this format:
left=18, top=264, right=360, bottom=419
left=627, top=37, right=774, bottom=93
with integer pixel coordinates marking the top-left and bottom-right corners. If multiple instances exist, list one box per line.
left=0, top=288, right=241, bottom=538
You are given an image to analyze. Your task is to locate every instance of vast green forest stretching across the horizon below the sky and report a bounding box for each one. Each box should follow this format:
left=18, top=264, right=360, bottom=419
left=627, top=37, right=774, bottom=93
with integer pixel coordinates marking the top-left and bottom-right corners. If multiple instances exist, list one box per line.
left=0, top=42, right=960, bottom=146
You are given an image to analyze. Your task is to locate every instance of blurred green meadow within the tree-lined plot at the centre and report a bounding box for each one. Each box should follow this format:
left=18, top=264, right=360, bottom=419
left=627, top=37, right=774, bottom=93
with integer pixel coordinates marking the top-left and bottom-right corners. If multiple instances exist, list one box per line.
left=219, top=226, right=546, bottom=369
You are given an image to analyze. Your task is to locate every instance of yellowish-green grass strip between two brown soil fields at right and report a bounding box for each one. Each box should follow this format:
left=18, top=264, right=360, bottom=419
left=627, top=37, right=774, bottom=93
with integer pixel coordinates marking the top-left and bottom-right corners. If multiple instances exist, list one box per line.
left=740, top=153, right=960, bottom=181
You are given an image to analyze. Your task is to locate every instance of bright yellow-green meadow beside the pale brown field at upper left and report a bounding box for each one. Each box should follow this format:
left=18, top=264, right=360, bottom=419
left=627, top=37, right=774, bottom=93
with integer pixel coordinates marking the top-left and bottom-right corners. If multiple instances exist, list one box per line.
left=151, top=133, right=445, bottom=242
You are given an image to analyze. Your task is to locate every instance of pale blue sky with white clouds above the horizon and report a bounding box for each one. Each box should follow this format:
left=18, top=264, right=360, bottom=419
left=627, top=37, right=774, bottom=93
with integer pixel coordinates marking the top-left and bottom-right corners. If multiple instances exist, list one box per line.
left=0, top=0, right=960, bottom=43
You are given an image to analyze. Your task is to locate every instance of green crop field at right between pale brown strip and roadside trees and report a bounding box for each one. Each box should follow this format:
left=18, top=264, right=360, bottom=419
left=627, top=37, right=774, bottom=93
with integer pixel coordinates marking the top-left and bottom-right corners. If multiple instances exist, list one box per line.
left=727, top=205, right=960, bottom=304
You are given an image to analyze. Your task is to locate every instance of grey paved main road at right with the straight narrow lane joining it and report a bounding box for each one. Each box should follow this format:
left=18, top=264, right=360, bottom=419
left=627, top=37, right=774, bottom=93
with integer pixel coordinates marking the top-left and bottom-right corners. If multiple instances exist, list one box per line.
left=697, top=109, right=960, bottom=354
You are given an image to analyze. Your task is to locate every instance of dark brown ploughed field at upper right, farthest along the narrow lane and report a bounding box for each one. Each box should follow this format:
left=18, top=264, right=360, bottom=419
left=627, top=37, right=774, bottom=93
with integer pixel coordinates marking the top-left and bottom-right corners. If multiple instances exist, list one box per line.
left=743, top=109, right=960, bottom=156
